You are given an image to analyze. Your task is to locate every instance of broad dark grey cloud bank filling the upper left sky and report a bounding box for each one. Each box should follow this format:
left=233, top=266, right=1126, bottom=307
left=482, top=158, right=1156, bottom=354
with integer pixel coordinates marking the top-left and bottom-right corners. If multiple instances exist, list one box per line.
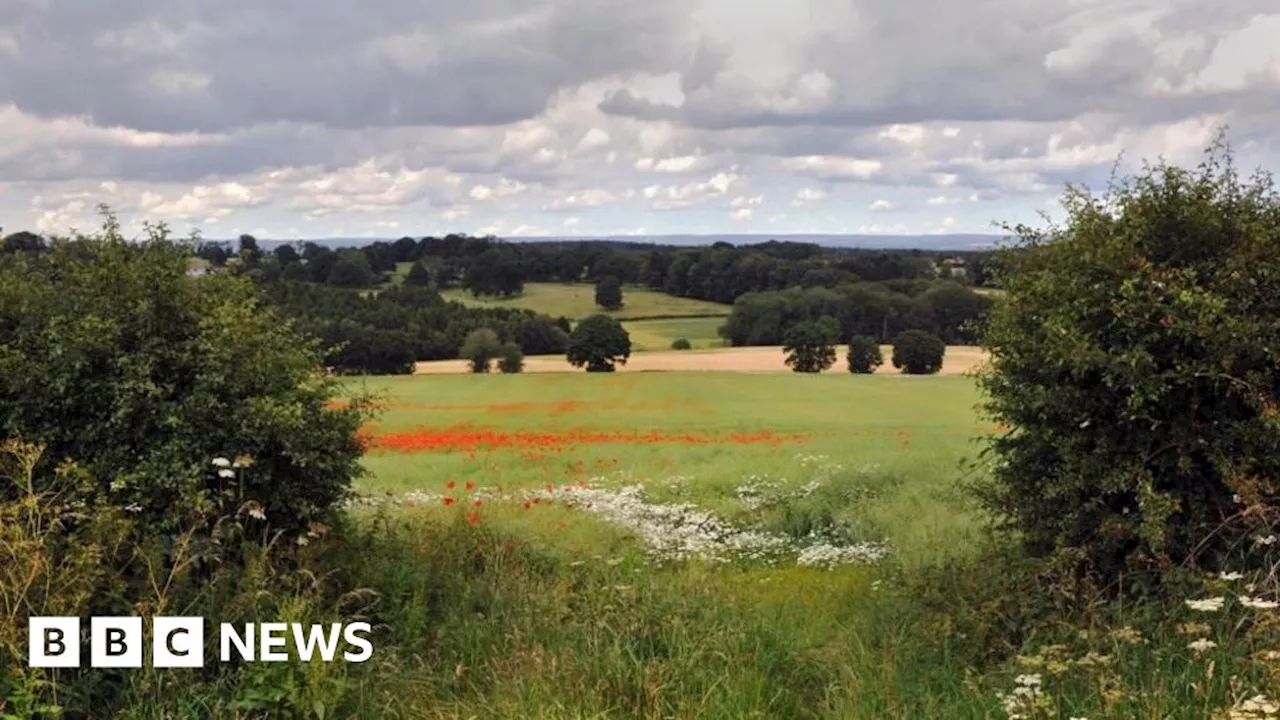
left=0, top=0, right=696, bottom=132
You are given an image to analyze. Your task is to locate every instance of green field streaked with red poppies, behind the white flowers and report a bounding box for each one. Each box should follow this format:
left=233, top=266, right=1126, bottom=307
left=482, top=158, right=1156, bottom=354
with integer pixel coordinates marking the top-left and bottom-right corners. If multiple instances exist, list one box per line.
left=345, top=373, right=986, bottom=560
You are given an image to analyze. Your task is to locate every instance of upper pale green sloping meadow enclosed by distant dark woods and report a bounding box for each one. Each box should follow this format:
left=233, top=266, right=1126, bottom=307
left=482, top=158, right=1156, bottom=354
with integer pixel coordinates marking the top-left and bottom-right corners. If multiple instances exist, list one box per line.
left=443, top=283, right=730, bottom=320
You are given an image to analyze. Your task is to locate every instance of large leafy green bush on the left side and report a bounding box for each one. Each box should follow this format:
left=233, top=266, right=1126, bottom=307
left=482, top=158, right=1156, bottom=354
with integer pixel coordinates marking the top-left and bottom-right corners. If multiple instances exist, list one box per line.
left=0, top=207, right=366, bottom=529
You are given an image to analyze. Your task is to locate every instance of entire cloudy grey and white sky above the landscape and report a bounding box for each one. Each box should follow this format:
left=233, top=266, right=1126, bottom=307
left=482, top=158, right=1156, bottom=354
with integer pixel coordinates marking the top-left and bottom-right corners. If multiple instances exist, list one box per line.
left=0, top=0, right=1280, bottom=238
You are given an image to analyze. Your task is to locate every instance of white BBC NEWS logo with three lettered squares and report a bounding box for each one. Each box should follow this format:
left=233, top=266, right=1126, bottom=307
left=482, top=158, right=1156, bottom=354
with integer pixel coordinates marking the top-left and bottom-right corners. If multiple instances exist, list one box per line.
left=27, top=618, right=374, bottom=667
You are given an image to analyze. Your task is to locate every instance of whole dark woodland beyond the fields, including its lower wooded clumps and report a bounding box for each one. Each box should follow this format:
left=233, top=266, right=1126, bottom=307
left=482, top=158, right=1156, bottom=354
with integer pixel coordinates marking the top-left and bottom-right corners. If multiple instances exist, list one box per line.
left=0, top=224, right=991, bottom=374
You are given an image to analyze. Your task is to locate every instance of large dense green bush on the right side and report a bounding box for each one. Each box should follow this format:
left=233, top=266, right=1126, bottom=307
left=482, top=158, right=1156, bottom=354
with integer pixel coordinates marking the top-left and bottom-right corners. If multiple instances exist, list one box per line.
left=980, top=138, right=1280, bottom=580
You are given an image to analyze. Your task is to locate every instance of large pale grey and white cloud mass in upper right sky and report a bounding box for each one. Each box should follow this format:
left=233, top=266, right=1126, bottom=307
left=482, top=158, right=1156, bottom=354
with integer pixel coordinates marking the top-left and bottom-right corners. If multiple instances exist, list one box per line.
left=600, top=0, right=1280, bottom=129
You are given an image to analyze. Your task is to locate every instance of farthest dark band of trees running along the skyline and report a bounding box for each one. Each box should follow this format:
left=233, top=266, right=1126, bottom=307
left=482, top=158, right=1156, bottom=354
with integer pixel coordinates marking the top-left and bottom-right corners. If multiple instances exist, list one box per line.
left=183, top=234, right=991, bottom=298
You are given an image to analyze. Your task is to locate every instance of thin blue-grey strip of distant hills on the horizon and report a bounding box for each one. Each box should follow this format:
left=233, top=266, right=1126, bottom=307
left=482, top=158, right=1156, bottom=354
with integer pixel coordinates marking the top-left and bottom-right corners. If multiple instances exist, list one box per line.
left=232, top=234, right=1005, bottom=250
